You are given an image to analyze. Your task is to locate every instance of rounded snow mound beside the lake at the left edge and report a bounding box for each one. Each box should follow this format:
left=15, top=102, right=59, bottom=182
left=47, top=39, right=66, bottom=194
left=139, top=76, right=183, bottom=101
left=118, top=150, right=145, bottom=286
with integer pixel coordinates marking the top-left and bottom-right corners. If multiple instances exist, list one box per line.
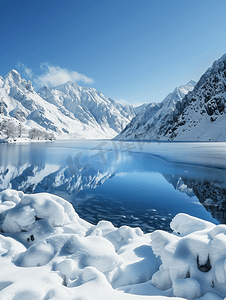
left=0, top=190, right=91, bottom=246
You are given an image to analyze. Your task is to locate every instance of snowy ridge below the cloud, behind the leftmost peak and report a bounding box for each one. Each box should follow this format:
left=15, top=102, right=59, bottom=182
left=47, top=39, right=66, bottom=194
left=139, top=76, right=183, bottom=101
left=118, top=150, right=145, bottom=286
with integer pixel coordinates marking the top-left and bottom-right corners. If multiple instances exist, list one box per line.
left=38, top=81, right=135, bottom=135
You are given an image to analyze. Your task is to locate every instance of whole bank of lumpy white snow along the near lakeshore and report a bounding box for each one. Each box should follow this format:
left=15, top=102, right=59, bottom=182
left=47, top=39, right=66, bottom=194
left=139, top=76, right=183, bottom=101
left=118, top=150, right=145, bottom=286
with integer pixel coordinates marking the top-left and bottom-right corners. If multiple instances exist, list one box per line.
left=0, top=190, right=226, bottom=300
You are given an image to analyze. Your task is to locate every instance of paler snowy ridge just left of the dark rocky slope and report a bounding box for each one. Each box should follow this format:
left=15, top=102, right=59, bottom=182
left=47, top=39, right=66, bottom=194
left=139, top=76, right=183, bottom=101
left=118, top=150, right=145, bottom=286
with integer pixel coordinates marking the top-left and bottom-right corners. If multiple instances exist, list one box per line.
left=116, top=81, right=196, bottom=140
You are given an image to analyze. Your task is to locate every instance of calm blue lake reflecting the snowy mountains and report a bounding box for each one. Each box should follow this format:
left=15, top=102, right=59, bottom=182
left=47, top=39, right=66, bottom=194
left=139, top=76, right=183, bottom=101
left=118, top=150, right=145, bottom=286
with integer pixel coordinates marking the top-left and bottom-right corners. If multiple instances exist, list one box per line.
left=0, top=140, right=226, bottom=232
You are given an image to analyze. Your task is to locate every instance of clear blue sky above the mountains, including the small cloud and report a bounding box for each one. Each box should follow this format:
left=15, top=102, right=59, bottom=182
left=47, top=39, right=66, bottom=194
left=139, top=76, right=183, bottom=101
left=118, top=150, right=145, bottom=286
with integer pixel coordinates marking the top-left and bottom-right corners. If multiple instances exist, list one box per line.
left=0, top=0, right=226, bottom=105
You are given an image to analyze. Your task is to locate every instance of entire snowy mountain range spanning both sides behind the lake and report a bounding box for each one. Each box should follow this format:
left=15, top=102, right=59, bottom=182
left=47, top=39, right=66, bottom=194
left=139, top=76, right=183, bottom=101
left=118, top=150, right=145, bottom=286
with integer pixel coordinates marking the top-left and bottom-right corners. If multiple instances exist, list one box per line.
left=0, top=54, right=226, bottom=141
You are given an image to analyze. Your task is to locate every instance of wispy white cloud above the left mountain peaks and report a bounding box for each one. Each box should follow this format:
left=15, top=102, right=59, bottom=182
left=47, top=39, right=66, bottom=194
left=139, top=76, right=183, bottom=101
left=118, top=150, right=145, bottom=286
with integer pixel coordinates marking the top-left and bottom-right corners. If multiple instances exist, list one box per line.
left=35, top=63, right=94, bottom=86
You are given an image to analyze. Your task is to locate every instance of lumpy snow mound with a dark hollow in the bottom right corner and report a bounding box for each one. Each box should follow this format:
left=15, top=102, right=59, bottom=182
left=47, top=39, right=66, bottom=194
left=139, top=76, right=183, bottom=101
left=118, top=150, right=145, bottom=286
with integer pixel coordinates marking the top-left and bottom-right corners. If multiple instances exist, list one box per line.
left=151, top=214, right=226, bottom=300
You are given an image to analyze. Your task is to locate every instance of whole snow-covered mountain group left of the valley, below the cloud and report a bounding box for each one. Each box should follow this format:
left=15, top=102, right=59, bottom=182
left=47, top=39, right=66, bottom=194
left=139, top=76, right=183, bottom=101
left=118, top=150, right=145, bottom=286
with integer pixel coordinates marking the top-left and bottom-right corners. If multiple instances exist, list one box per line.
left=0, top=70, right=136, bottom=139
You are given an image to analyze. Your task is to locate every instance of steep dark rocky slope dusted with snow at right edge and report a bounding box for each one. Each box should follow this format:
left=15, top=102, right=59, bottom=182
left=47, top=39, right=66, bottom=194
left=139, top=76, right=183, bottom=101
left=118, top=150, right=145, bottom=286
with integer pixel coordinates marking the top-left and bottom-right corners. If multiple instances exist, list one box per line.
left=161, top=54, right=226, bottom=141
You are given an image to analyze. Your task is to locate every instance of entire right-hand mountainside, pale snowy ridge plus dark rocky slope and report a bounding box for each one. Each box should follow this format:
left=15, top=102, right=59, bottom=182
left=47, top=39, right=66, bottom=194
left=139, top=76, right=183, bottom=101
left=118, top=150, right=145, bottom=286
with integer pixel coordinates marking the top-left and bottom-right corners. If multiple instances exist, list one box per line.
left=116, top=54, right=226, bottom=141
